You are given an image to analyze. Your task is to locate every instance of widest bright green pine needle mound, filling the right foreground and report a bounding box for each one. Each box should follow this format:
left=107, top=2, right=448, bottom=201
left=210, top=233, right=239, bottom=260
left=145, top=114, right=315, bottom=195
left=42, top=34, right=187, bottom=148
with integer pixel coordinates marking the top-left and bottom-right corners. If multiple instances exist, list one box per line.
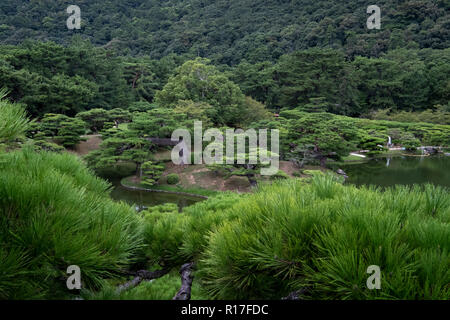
left=199, top=176, right=450, bottom=299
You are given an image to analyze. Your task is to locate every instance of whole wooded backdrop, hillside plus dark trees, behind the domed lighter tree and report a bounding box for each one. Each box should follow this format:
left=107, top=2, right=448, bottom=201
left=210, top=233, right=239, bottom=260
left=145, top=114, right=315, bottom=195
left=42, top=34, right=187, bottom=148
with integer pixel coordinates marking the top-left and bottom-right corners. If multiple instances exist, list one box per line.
left=0, top=0, right=450, bottom=120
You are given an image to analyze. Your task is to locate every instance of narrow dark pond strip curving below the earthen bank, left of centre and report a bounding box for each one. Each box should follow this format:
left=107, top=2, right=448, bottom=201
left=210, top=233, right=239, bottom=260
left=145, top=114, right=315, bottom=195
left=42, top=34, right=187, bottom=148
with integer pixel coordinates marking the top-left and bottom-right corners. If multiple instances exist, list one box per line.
left=108, top=178, right=205, bottom=211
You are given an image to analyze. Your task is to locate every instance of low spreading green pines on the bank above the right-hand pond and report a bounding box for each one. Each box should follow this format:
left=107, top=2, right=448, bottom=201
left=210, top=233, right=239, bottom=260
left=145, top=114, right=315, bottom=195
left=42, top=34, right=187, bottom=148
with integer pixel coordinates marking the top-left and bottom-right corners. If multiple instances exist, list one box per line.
left=278, top=109, right=450, bottom=167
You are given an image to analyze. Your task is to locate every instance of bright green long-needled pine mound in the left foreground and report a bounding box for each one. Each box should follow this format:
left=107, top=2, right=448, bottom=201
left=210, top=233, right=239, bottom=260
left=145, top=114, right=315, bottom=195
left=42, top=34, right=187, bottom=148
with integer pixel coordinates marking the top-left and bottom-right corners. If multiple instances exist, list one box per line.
left=0, top=150, right=142, bottom=299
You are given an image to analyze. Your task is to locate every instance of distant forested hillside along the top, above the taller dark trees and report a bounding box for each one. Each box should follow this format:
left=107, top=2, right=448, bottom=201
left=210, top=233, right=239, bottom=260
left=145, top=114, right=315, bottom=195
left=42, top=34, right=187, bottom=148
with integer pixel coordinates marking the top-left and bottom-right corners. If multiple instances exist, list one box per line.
left=0, top=0, right=450, bottom=64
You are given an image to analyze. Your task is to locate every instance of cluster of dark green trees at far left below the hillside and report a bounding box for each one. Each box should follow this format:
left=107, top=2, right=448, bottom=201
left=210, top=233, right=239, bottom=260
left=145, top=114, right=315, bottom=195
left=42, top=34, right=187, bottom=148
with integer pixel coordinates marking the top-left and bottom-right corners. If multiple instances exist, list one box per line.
left=0, top=39, right=130, bottom=117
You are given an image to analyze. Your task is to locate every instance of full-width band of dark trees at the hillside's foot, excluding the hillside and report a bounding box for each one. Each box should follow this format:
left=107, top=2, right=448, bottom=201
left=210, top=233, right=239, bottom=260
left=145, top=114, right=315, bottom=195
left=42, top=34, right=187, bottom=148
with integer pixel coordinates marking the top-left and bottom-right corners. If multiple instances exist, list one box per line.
left=0, top=39, right=450, bottom=124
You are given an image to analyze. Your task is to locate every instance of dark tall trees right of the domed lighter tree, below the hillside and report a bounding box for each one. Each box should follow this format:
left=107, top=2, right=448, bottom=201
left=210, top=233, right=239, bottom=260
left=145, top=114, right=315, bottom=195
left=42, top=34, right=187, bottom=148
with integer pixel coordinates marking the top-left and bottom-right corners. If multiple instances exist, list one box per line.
left=230, top=49, right=450, bottom=117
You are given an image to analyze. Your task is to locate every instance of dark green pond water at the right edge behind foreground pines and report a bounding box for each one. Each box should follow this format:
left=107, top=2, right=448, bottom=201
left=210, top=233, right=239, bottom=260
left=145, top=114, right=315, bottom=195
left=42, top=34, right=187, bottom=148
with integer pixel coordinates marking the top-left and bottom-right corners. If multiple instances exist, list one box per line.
left=336, top=156, right=450, bottom=187
